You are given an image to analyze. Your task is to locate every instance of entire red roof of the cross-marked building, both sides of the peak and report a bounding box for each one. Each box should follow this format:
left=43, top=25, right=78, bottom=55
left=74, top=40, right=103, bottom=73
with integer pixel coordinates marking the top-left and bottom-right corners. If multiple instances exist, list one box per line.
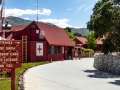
left=0, top=21, right=74, bottom=46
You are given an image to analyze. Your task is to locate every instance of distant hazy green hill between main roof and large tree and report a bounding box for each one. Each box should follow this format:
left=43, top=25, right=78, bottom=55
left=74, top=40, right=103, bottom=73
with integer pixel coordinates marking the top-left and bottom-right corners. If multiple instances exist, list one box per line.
left=71, top=28, right=89, bottom=36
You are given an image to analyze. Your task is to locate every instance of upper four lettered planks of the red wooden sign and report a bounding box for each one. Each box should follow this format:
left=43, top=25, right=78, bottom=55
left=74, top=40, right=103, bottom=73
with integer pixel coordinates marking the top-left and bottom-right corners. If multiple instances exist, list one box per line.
left=0, top=40, right=22, bottom=64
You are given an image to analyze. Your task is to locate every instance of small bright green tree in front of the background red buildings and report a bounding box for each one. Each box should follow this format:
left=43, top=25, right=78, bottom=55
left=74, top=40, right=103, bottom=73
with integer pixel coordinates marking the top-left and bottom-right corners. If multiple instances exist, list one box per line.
left=86, top=31, right=97, bottom=49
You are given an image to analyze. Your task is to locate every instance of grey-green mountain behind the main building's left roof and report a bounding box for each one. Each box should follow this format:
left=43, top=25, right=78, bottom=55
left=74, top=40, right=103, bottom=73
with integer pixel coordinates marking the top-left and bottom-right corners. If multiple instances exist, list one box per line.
left=7, top=16, right=32, bottom=26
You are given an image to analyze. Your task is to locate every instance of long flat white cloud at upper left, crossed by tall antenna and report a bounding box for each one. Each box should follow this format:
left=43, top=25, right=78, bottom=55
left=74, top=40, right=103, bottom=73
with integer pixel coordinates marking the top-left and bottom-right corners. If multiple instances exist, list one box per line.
left=5, top=8, right=51, bottom=17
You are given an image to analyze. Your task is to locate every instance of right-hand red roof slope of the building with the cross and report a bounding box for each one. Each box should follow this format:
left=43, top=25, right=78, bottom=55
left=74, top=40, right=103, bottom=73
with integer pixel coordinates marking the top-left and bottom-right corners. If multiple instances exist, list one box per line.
left=36, top=22, right=74, bottom=46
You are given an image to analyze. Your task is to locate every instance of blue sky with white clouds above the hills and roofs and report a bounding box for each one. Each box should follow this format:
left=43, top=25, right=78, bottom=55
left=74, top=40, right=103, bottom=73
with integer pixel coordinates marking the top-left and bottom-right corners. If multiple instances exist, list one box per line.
left=1, top=0, right=98, bottom=28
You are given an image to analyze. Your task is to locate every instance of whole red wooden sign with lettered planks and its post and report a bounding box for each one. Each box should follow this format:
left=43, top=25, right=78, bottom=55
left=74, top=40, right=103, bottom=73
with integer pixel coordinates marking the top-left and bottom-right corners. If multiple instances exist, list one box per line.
left=0, top=40, right=22, bottom=90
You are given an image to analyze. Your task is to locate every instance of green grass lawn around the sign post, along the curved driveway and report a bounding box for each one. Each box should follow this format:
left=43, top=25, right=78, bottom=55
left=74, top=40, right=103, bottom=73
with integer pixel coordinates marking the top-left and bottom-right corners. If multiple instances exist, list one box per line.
left=0, top=62, right=46, bottom=90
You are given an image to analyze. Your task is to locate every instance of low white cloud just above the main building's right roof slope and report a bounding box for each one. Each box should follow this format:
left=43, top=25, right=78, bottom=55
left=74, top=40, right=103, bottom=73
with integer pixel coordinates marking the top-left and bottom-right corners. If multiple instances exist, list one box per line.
left=39, top=18, right=80, bottom=28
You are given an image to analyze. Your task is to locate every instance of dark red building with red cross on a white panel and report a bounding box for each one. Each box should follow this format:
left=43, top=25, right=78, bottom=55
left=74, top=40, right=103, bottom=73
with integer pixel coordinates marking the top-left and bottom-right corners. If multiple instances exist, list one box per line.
left=1, top=21, right=74, bottom=62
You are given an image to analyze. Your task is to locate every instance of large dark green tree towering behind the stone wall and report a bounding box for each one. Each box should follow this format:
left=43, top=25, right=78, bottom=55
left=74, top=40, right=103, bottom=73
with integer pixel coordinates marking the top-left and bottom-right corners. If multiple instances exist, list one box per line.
left=87, top=0, right=120, bottom=54
